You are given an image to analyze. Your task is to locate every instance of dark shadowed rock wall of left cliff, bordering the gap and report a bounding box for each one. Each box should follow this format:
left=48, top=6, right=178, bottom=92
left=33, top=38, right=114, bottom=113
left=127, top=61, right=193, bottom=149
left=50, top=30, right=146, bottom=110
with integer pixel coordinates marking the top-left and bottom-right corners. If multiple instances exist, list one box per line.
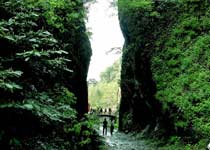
left=46, top=0, right=92, bottom=116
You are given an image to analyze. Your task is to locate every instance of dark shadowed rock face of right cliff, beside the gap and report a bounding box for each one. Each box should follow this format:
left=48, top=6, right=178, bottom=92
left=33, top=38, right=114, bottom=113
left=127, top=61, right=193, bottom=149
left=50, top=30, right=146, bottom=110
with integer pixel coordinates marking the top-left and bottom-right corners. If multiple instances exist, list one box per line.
left=119, top=1, right=176, bottom=130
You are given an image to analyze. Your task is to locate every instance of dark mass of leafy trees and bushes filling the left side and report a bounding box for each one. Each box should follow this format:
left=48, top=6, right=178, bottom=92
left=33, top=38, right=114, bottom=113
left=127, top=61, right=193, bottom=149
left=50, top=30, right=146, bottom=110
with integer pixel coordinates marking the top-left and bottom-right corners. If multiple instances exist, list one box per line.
left=0, top=0, right=98, bottom=150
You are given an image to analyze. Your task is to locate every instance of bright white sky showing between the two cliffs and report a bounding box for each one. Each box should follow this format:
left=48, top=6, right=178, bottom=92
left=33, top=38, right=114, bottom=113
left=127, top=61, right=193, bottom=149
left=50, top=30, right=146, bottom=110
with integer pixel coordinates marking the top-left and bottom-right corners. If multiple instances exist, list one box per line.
left=86, top=0, right=124, bottom=80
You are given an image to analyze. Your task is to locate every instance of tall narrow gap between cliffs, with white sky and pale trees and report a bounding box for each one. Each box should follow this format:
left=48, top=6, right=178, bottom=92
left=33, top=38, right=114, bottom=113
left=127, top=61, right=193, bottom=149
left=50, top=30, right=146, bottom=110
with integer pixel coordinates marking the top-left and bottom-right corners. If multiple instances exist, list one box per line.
left=85, top=0, right=124, bottom=135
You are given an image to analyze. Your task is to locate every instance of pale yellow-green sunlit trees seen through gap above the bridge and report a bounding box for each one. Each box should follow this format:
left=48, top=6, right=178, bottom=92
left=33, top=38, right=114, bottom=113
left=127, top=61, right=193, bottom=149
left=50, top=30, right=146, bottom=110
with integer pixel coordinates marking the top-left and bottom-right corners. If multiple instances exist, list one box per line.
left=89, top=60, right=121, bottom=111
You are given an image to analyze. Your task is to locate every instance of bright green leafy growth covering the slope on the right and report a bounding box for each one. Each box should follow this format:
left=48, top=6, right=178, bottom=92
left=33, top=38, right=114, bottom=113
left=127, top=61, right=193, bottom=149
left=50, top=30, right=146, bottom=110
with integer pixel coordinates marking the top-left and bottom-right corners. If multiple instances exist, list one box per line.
left=152, top=9, right=210, bottom=136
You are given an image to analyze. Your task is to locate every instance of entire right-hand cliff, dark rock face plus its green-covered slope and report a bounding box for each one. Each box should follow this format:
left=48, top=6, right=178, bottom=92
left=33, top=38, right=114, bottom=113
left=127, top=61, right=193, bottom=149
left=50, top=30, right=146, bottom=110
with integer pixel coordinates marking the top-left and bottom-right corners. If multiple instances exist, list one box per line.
left=118, top=0, right=210, bottom=139
